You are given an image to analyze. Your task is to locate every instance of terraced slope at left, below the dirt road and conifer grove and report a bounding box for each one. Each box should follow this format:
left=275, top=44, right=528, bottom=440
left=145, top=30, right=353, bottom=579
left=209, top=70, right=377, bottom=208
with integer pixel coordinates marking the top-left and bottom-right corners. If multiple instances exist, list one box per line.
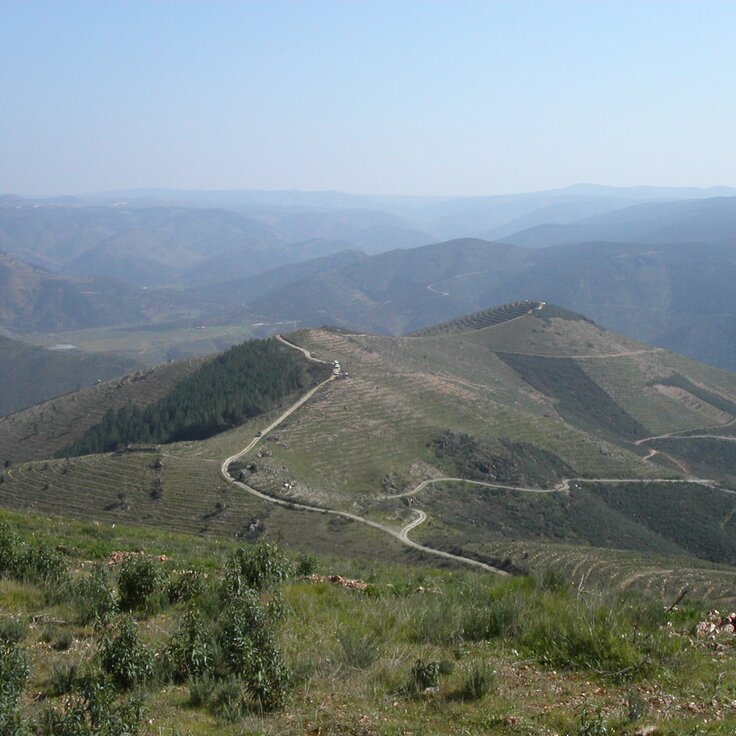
left=0, top=452, right=414, bottom=563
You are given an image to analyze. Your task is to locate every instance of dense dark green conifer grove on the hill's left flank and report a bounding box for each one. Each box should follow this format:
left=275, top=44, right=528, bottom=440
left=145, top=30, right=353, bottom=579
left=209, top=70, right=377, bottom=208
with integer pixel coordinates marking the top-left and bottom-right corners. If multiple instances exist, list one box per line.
left=59, top=339, right=328, bottom=456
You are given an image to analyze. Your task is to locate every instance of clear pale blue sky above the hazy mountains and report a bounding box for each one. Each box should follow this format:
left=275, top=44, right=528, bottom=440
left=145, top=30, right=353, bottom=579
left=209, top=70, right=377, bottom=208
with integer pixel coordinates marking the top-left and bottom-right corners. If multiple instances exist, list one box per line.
left=0, top=0, right=736, bottom=194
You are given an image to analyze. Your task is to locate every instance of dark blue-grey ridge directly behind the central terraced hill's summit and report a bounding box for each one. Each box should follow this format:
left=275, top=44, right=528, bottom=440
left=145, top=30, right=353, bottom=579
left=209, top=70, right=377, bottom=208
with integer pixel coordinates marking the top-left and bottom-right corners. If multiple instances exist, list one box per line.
left=234, top=239, right=736, bottom=368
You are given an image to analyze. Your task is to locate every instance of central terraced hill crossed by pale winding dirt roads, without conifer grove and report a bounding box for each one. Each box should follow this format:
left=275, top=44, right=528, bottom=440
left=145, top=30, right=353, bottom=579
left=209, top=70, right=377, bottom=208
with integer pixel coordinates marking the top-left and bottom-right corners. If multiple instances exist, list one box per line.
left=0, top=305, right=736, bottom=597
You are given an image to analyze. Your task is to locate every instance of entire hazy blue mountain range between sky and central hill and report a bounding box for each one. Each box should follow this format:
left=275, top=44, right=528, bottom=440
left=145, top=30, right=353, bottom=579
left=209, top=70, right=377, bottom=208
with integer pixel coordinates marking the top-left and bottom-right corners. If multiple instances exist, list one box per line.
left=0, top=185, right=736, bottom=414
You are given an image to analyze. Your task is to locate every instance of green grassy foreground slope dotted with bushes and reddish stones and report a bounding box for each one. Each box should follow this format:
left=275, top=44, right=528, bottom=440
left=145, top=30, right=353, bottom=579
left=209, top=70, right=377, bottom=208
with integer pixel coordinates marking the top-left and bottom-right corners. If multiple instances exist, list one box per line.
left=0, top=517, right=736, bottom=736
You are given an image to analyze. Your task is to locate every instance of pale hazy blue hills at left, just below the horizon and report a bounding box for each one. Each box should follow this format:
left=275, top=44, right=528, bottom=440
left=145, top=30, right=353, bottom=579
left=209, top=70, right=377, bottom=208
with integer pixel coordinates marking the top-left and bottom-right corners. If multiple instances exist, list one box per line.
left=0, top=200, right=433, bottom=287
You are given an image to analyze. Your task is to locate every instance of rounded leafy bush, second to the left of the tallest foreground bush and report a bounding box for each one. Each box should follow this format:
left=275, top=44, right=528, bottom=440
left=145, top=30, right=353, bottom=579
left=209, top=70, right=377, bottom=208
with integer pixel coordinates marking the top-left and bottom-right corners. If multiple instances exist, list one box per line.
left=98, top=617, right=153, bottom=690
